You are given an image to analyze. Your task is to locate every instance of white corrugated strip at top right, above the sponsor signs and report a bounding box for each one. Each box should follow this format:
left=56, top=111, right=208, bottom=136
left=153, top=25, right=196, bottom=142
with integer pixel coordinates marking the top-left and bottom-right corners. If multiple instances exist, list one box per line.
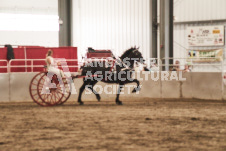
left=174, top=0, right=226, bottom=22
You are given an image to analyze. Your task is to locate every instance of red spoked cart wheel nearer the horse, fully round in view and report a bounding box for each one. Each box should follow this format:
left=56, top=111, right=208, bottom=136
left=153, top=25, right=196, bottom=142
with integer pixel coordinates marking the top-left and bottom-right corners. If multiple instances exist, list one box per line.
left=38, top=74, right=71, bottom=106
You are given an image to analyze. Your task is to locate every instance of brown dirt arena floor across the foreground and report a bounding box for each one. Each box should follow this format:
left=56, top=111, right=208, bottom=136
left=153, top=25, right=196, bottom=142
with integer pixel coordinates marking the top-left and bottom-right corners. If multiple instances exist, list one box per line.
left=0, top=99, right=226, bottom=151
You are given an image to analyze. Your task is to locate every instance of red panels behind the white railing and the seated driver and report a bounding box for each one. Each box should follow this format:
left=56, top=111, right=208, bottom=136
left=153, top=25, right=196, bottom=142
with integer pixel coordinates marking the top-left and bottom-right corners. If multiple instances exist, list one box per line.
left=5, top=47, right=78, bottom=72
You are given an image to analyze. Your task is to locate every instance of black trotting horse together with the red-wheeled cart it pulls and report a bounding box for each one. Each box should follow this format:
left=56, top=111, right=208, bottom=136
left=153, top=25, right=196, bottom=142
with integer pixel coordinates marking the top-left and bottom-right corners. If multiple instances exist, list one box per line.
left=29, top=47, right=144, bottom=106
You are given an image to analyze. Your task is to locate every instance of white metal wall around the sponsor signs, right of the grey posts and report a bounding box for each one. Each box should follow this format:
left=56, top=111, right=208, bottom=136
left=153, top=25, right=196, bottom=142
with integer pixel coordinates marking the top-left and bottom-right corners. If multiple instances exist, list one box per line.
left=170, top=0, right=226, bottom=72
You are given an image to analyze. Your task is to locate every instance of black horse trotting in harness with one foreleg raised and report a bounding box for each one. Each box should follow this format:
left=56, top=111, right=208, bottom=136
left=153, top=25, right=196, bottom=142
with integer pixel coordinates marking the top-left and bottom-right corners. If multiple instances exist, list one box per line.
left=78, top=47, right=145, bottom=105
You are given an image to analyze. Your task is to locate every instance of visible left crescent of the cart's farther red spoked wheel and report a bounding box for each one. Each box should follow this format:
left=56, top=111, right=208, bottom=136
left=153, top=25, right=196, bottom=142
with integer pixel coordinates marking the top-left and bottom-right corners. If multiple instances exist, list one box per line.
left=29, top=72, right=48, bottom=106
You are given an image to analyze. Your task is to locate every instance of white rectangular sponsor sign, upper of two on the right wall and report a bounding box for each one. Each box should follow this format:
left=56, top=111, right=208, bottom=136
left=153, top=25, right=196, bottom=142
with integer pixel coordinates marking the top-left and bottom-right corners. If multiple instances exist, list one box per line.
left=187, top=26, right=224, bottom=46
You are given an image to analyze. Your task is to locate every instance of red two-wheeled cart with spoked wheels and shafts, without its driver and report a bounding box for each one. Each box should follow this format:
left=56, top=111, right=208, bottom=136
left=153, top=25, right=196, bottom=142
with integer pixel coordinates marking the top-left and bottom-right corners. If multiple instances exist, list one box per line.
left=29, top=59, right=115, bottom=106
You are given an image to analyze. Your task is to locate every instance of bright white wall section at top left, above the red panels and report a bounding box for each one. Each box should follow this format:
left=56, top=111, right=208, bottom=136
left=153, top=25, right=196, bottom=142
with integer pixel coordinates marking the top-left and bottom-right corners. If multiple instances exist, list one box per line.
left=0, top=0, right=59, bottom=46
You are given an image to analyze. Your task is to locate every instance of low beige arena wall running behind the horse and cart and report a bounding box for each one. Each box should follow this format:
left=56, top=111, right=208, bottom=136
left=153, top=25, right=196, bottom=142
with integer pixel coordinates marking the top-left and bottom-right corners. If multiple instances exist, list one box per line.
left=0, top=72, right=226, bottom=102
